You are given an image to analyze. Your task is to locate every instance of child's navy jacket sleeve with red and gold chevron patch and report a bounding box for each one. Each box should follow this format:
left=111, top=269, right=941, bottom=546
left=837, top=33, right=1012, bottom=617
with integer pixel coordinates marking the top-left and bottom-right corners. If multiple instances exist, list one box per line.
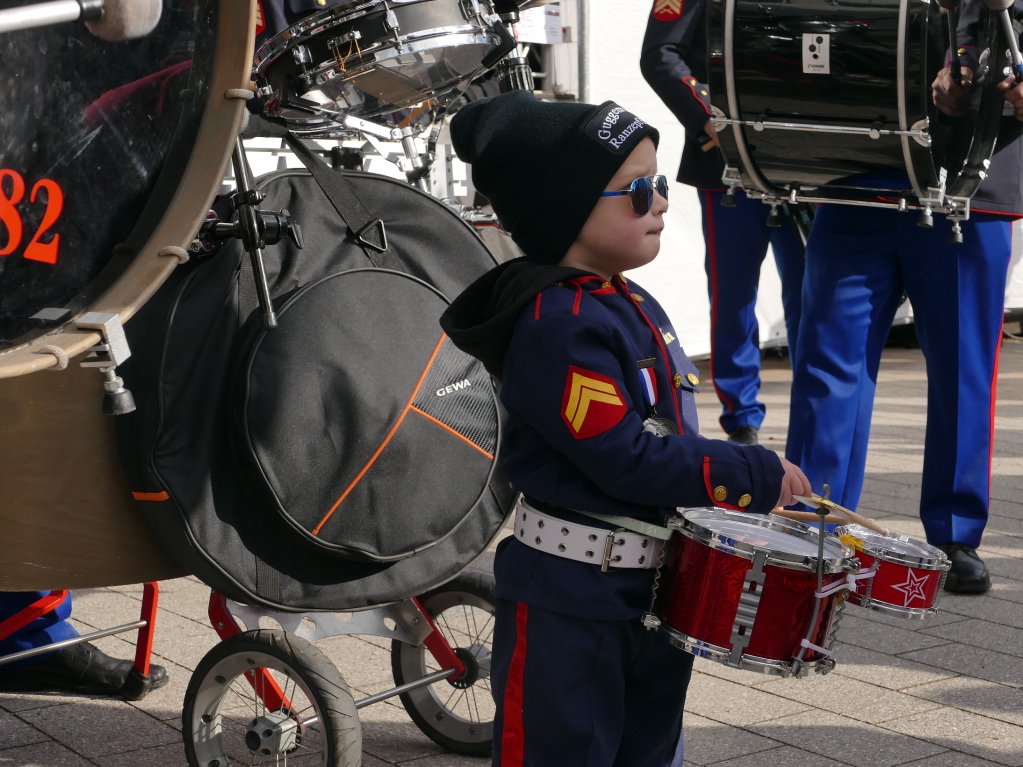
left=501, top=288, right=783, bottom=515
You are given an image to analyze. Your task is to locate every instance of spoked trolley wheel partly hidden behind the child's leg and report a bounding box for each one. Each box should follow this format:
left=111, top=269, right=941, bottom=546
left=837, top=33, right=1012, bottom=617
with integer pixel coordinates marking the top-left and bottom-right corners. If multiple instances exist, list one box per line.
left=391, top=573, right=495, bottom=756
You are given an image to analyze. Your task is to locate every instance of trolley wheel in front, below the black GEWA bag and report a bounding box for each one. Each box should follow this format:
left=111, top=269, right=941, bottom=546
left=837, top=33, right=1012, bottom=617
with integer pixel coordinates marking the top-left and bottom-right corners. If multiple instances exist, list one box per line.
left=181, top=629, right=362, bottom=767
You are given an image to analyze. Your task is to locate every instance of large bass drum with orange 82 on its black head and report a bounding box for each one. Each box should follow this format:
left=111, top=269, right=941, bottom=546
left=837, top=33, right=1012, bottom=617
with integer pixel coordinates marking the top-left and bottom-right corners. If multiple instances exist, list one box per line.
left=0, top=0, right=255, bottom=591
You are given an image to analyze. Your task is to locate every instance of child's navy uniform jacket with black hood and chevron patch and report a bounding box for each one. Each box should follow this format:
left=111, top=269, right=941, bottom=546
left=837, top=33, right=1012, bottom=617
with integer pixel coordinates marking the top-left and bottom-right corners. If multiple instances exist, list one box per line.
left=441, top=259, right=784, bottom=620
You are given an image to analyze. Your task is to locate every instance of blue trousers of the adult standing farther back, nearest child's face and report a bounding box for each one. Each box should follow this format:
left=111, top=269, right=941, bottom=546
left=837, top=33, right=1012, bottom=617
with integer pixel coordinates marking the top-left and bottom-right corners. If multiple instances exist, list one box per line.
left=700, top=189, right=805, bottom=433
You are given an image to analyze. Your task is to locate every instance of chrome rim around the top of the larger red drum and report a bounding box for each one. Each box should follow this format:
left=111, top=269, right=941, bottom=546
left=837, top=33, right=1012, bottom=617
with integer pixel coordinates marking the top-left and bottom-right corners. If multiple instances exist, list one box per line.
left=667, top=506, right=859, bottom=575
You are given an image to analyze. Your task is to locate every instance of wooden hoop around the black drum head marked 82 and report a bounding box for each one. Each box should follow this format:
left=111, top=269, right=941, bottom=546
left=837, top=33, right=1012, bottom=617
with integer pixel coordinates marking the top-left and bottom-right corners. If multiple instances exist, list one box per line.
left=0, top=0, right=256, bottom=378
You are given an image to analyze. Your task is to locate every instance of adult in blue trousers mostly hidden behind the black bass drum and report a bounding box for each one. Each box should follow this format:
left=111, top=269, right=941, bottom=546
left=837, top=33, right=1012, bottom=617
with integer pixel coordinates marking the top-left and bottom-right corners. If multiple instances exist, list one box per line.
left=639, top=0, right=804, bottom=445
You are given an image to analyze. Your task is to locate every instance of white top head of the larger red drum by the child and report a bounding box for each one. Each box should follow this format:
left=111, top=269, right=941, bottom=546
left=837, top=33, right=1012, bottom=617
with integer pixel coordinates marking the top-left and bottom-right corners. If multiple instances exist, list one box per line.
left=679, top=508, right=855, bottom=572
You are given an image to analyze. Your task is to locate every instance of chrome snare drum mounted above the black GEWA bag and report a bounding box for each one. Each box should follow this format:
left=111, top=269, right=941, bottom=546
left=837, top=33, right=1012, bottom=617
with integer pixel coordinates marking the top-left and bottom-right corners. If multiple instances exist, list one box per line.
left=254, top=0, right=515, bottom=137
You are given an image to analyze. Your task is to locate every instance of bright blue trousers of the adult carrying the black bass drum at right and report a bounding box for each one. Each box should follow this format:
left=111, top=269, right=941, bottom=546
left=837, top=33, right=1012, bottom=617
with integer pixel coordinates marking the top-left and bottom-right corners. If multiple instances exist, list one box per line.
left=786, top=205, right=1012, bottom=546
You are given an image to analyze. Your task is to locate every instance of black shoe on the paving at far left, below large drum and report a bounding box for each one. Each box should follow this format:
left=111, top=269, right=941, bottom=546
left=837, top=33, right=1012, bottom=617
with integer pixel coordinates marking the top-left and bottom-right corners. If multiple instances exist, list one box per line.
left=0, top=642, right=168, bottom=695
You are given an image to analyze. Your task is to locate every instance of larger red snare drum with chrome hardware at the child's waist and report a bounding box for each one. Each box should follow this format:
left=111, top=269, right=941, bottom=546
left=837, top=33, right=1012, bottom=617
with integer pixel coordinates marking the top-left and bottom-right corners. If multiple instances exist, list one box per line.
left=647, top=508, right=859, bottom=676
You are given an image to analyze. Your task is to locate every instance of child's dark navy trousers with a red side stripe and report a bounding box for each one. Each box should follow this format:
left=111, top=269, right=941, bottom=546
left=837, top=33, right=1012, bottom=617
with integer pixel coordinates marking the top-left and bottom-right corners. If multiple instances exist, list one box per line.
left=491, top=599, right=693, bottom=767
